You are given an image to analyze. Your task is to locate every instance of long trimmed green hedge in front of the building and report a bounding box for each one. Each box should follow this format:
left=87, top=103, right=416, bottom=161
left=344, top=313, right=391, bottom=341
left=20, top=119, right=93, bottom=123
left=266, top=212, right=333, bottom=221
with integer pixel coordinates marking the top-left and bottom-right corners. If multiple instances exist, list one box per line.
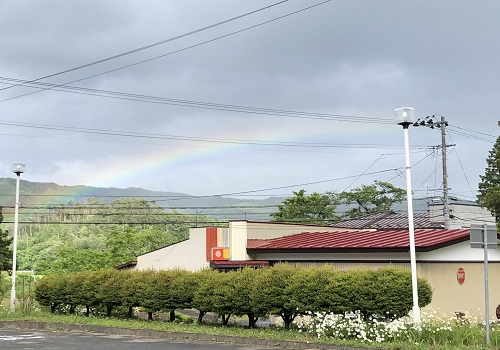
left=35, top=264, right=432, bottom=328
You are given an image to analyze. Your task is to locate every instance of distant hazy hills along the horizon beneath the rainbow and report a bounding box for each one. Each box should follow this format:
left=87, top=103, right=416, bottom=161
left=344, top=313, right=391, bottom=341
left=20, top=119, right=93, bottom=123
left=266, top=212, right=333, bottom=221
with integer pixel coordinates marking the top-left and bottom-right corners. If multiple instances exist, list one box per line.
left=0, top=178, right=428, bottom=221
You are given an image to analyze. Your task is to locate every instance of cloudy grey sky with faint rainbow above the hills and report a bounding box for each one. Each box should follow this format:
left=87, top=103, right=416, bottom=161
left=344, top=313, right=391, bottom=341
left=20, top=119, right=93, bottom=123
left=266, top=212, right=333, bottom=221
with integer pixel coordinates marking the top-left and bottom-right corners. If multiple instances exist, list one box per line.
left=0, top=0, right=500, bottom=199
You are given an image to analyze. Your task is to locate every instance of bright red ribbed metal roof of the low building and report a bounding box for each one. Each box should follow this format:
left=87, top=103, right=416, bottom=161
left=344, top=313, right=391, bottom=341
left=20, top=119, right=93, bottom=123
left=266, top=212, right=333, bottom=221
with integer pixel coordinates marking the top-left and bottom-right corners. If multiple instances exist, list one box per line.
left=247, top=229, right=470, bottom=252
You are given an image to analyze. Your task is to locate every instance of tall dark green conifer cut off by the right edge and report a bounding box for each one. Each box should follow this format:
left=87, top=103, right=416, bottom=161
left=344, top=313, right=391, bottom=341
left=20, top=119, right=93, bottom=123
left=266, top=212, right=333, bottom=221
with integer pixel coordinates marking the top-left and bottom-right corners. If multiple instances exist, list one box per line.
left=477, top=137, right=500, bottom=226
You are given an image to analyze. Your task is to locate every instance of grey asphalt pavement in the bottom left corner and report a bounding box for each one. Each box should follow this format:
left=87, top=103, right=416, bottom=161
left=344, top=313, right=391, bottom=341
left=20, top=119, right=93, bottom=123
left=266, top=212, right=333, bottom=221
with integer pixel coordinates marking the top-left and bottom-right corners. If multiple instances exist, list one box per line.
left=0, top=329, right=277, bottom=350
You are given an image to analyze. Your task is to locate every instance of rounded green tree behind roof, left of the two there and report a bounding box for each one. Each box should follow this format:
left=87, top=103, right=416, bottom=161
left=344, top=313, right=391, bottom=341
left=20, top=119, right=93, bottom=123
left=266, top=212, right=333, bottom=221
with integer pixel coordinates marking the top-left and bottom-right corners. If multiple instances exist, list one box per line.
left=271, top=190, right=338, bottom=224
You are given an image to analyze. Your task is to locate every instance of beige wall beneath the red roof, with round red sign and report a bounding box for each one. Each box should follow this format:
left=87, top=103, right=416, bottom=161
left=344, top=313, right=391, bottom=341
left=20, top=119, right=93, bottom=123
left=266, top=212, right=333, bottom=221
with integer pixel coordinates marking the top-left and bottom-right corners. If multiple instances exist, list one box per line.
left=252, top=246, right=500, bottom=319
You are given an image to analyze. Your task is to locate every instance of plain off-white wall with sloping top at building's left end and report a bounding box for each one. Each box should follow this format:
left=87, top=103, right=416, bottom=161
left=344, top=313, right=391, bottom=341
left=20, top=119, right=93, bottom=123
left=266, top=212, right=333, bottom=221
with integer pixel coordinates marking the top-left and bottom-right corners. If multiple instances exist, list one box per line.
left=134, top=228, right=210, bottom=271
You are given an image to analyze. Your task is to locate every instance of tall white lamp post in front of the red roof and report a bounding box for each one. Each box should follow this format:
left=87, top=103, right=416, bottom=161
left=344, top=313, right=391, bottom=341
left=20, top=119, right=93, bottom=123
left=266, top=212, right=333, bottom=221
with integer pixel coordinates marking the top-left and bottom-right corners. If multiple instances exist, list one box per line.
left=395, top=107, right=420, bottom=325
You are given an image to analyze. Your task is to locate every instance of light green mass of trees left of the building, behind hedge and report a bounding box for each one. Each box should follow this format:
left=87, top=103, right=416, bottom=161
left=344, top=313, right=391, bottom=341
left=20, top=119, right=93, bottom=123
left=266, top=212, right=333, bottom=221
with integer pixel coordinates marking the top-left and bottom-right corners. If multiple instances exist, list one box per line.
left=15, top=198, right=194, bottom=274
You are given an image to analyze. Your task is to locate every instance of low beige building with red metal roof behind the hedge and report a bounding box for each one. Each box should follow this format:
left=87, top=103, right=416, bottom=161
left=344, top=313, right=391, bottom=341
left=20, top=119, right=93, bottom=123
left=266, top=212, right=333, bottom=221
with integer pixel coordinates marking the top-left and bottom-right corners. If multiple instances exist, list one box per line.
left=120, top=221, right=500, bottom=317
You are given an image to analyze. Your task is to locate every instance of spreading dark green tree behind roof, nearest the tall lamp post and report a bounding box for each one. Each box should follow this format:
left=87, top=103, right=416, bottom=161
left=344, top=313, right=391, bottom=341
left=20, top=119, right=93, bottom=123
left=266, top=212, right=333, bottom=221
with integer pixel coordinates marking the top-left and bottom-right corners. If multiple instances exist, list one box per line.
left=331, top=180, right=406, bottom=218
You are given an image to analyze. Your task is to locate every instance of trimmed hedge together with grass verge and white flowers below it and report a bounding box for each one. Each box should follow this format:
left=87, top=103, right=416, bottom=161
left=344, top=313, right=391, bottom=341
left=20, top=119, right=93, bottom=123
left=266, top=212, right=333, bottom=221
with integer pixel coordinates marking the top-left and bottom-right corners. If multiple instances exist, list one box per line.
left=0, top=265, right=500, bottom=349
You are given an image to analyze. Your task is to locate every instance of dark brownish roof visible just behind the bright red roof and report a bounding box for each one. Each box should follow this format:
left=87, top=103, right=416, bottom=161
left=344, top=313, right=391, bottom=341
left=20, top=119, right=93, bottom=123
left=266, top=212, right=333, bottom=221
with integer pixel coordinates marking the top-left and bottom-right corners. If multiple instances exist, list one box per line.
left=330, top=211, right=443, bottom=230
